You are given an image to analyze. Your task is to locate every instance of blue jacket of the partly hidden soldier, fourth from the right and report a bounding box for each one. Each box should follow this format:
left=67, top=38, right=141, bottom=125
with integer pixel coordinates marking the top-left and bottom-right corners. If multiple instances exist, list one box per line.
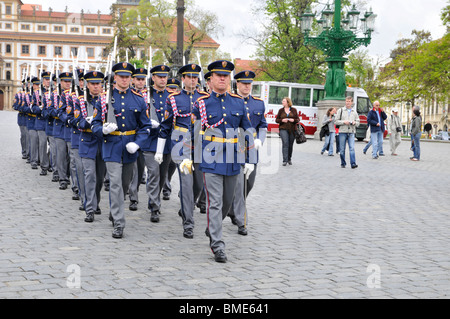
left=141, top=89, right=170, bottom=154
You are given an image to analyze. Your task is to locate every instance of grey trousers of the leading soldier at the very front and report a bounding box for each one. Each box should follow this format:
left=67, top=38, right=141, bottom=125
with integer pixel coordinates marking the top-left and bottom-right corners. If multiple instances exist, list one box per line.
left=203, top=173, right=239, bottom=253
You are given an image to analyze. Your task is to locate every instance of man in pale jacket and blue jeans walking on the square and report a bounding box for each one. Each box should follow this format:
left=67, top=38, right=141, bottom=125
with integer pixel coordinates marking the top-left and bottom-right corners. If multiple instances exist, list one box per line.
left=335, top=96, right=359, bottom=168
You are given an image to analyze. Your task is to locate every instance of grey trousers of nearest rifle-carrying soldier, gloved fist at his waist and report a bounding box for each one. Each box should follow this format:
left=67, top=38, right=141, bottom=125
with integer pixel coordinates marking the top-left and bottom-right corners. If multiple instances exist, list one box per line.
left=106, top=162, right=134, bottom=228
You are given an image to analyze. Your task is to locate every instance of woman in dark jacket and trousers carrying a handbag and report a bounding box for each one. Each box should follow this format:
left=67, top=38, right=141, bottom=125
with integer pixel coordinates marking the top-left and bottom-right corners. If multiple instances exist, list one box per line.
left=275, top=97, right=300, bottom=166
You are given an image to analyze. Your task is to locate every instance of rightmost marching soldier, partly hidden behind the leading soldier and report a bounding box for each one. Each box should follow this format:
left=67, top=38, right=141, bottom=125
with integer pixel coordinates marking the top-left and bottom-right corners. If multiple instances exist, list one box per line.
left=228, top=71, right=267, bottom=236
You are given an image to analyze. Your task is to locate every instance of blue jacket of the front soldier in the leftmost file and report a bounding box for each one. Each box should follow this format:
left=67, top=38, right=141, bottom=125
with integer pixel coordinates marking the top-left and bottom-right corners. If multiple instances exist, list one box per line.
left=73, top=97, right=103, bottom=159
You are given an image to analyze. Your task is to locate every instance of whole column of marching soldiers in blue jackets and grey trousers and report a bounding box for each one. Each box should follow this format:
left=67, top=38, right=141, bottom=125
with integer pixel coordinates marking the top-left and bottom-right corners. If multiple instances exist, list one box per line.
left=14, top=60, right=267, bottom=262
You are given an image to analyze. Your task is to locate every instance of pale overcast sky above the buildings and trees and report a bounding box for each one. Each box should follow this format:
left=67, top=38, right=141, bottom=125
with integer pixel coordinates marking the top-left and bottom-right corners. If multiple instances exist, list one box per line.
left=31, top=0, right=447, bottom=63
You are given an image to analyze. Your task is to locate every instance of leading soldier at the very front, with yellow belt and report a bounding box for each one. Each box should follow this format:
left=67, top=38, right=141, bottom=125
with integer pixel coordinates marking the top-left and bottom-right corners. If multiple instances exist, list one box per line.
left=193, top=60, right=256, bottom=262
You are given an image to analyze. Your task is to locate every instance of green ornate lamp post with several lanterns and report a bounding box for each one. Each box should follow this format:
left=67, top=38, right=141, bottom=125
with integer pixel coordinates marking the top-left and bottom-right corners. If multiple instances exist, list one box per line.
left=301, top=0, right=376, bottom=100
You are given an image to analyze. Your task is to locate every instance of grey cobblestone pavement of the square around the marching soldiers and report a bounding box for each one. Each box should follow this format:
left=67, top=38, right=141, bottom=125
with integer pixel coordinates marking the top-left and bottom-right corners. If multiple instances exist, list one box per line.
left=0, top=111, right=450, bottom=299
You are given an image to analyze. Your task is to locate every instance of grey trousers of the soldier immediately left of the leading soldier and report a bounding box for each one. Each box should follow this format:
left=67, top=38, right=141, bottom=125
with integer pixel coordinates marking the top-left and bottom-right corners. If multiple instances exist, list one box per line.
left=177, top=164, right=203, bottom=229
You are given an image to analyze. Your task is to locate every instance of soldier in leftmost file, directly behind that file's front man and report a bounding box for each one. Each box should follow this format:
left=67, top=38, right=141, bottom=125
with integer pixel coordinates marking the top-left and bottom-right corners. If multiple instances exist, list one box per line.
left=54, top=72, right=73, bottom=190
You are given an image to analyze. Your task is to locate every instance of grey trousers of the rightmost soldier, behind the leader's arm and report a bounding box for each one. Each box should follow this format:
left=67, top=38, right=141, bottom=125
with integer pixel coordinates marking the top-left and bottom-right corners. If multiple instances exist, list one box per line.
left=232, top=165, right=256, bottom=227
